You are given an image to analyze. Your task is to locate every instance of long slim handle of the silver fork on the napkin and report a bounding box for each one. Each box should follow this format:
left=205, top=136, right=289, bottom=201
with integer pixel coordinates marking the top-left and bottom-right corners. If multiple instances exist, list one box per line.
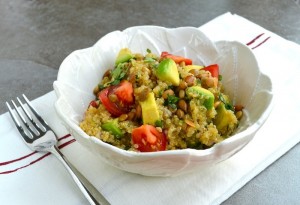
left=50, top=146, right=103, bottom=205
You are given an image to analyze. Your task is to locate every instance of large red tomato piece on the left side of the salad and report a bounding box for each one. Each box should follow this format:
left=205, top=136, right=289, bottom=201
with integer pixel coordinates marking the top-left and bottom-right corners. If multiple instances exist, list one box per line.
left=98, top=81, right=134, bottom=117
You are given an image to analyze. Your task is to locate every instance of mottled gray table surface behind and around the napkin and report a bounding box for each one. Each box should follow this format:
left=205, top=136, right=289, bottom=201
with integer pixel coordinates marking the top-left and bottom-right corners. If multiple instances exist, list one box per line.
left=0, top=0, right=300, bottom=205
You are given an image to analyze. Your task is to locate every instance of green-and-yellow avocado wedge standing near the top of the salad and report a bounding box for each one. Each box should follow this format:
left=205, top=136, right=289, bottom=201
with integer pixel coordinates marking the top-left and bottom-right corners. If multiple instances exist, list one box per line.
left=156, top=58, right=180, bottom=86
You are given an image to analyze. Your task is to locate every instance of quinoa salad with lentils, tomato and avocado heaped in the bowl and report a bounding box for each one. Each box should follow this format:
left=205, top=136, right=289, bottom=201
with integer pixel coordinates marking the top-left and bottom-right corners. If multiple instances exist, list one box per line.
left=80, top=48, right=243, bottom=152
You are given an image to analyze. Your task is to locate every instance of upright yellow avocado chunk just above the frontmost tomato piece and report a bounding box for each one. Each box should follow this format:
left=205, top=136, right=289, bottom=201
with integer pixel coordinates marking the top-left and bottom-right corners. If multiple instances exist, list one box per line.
left=139, top=92, right=160, bottom=125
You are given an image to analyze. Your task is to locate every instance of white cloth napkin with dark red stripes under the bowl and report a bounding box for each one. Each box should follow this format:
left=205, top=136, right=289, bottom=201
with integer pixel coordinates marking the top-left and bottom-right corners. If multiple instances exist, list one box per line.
left=0, top=13, right=300, bottom=205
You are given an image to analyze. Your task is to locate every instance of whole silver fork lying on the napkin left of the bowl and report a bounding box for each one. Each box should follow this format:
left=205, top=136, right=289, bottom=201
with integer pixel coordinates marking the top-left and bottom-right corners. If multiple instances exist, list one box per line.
left=6, top=94, right=108, bottom=204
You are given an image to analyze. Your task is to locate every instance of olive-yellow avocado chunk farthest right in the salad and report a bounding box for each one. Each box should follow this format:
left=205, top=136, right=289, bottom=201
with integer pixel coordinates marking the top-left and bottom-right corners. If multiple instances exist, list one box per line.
left=214, top=102, right=238, bottom=136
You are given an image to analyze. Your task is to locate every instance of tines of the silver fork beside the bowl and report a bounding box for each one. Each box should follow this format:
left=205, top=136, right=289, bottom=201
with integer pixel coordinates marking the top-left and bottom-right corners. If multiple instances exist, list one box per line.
left=6, top=94, right=48, bottom=143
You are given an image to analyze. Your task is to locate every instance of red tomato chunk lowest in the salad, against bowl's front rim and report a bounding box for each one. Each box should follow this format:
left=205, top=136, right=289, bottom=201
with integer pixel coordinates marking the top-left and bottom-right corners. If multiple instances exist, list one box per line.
left=131, top=125, right=167, bottom=152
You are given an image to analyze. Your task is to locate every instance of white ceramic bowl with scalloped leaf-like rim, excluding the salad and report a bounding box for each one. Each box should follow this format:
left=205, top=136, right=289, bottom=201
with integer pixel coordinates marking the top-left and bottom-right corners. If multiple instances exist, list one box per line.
left=54, top=26, right=273, bottom=176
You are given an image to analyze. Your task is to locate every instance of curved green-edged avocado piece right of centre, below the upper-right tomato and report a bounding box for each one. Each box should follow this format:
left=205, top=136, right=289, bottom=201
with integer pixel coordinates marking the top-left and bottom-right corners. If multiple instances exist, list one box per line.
left=186, top=85, right=215, bottom=110
